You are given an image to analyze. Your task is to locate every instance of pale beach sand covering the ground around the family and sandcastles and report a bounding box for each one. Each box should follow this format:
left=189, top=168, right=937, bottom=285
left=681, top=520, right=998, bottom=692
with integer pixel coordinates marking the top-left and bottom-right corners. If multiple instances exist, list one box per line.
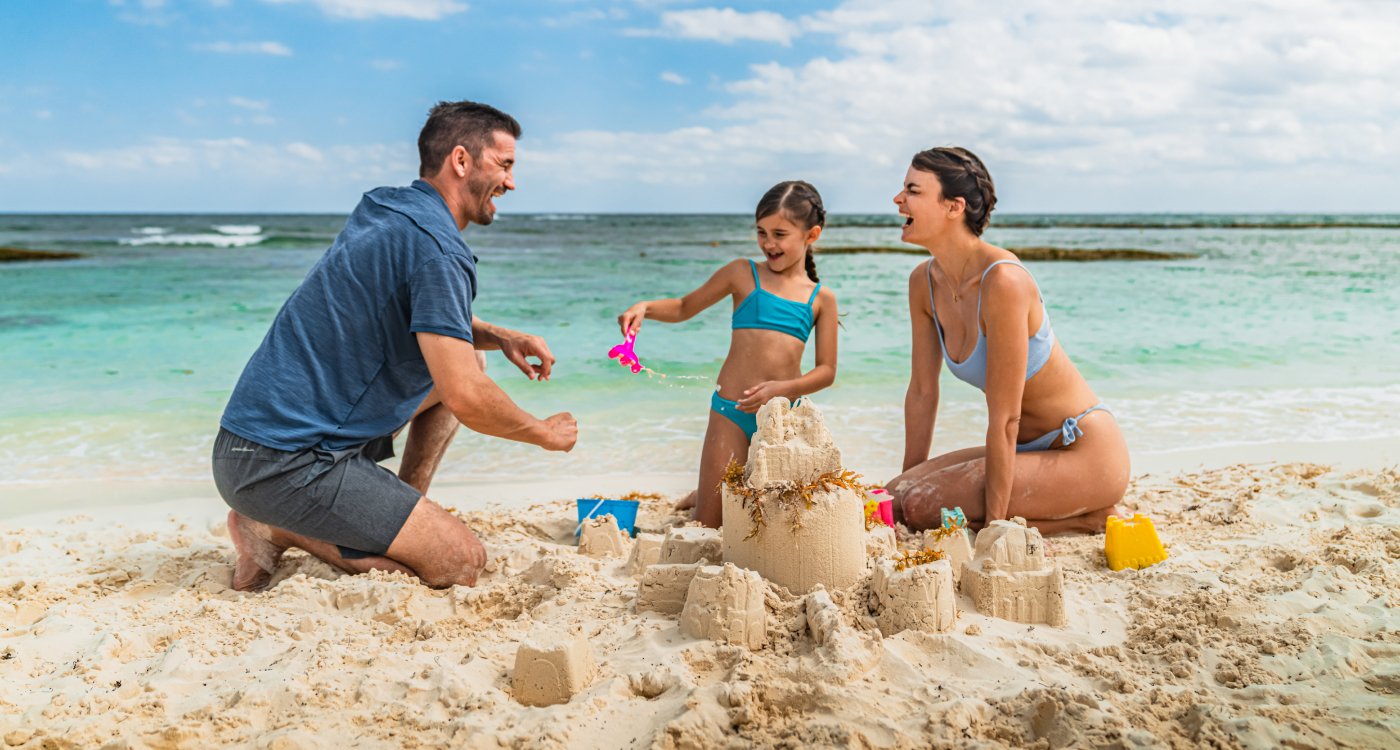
left=0, top=465, right=1400, bottom=749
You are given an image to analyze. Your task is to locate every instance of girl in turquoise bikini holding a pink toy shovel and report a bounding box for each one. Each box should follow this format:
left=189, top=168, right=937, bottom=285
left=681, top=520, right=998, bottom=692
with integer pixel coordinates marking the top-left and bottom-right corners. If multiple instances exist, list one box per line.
left=617, top=181, right=837, bottom=528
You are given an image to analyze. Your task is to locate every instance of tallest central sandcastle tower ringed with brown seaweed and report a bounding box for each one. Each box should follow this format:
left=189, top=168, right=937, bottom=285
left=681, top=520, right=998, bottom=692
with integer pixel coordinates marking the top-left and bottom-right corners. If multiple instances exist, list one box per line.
left=722, top=397, right=865, bottom=593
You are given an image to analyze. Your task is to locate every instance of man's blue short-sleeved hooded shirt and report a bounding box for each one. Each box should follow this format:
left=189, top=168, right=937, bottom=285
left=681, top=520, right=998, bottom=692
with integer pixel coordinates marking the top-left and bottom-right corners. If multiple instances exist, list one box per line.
left=221, top=181, right=476, bottom=451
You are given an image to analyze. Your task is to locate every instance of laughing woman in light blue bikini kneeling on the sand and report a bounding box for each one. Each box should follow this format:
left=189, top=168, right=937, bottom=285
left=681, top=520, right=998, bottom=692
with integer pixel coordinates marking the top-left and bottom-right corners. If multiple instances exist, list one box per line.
left=888, top=148, right=1128, bottom=533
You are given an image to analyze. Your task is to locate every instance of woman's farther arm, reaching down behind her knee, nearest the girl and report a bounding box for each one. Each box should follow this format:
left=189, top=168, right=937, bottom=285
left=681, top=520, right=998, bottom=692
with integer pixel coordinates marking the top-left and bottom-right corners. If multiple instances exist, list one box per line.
left=903, top=263, right=944, bottom=472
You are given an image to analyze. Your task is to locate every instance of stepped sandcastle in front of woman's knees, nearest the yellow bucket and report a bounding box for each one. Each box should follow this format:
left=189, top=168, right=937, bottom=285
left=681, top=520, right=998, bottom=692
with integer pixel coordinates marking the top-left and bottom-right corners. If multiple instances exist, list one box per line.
left=962, top=518, right=1065, bottom=627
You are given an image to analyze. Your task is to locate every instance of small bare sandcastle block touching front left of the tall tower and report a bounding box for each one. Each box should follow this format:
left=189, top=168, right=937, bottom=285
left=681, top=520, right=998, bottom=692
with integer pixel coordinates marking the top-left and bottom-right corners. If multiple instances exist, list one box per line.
left=680, top=564, right=769, bottom=648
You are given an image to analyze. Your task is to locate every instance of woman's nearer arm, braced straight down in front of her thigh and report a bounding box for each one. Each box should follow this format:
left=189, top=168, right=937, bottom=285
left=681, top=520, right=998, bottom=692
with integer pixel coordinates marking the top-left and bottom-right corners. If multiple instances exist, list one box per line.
left=981, top=266, right=1036, bottom=522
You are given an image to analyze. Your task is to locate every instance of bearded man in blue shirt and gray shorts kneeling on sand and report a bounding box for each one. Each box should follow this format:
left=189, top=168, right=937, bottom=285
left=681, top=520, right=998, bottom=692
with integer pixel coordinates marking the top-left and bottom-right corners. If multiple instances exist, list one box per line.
left=213, top=101, right=578, bottom=590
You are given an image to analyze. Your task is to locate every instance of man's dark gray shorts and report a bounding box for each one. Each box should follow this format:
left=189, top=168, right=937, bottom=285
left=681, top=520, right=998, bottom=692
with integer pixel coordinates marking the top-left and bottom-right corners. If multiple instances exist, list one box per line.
left=213, top=428, right=421, bottom=558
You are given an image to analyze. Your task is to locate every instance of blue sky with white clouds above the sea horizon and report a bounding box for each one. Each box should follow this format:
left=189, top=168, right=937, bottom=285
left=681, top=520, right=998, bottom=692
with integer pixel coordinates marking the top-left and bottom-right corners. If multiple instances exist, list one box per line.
left=0, top=0, right=1400, bottom=214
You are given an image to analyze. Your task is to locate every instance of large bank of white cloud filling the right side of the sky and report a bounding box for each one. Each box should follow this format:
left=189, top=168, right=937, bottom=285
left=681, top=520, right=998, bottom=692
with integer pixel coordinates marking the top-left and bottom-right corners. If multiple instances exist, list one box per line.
left=532, top=0, right=1400, bottom=210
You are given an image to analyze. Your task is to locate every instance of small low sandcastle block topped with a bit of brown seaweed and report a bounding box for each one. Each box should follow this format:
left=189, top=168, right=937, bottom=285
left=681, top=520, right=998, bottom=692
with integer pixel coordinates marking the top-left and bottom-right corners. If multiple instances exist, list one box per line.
left=871, top=560, right=958, bottom=637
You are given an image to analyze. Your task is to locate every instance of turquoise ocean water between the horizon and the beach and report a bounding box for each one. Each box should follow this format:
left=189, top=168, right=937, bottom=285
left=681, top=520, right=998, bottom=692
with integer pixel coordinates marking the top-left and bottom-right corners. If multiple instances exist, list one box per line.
left=0, top=214, right=1400, bottom=486
